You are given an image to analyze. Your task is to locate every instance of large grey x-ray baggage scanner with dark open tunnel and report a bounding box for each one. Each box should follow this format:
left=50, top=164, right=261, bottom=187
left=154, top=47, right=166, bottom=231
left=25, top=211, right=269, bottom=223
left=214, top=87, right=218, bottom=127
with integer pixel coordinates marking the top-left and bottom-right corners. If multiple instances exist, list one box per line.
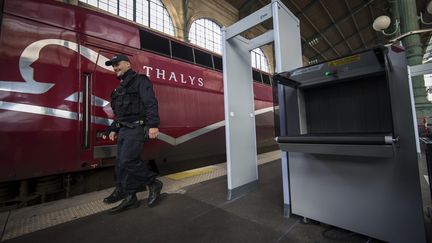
left=274, top=46, right=425, bottom=242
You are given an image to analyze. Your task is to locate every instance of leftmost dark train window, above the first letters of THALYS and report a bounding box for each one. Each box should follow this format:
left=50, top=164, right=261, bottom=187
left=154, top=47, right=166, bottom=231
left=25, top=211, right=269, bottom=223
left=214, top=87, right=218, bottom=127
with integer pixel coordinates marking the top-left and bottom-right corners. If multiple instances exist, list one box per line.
left=140, top=29, right=171, bottom=56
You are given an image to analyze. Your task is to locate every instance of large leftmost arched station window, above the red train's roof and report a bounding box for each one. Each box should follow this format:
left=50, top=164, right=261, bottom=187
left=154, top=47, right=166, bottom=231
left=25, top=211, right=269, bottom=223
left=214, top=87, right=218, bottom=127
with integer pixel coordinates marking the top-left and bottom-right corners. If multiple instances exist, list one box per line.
left=80, top=0, right=175, bottom=36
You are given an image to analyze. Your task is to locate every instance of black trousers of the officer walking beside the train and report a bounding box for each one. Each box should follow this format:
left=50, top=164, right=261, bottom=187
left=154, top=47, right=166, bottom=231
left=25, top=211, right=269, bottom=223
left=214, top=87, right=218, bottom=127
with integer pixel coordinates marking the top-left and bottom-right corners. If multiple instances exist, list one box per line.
left=115, top=126, right=156, bottom=194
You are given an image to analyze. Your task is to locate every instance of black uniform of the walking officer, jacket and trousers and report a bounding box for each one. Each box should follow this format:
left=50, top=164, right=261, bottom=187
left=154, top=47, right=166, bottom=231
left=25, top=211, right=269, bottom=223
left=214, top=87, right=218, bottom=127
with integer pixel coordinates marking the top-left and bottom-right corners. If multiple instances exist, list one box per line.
left=110, top=69, right=159, bottom=195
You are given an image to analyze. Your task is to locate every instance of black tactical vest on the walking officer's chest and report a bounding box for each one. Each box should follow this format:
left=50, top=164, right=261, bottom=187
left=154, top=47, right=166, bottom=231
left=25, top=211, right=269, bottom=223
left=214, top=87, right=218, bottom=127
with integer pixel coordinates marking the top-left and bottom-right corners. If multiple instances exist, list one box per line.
left=111, top=74, right=145, bottom=122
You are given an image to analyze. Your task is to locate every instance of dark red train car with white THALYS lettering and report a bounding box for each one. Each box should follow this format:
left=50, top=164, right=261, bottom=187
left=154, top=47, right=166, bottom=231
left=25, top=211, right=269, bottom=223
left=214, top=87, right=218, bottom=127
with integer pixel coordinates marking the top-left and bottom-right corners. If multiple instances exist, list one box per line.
left=0, top=0, right=276, bottom=205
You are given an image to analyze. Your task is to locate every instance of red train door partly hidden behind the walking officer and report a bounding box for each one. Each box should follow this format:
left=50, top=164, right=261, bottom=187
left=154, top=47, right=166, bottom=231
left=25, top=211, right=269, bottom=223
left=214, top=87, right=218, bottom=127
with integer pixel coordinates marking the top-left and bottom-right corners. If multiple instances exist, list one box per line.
left=80, top=44, right=132, bottom=167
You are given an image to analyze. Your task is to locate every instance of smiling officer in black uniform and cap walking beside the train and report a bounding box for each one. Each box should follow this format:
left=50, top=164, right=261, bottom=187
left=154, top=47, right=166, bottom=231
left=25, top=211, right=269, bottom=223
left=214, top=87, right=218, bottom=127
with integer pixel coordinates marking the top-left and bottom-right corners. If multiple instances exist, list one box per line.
left=103, top=54, right=163, bottom=213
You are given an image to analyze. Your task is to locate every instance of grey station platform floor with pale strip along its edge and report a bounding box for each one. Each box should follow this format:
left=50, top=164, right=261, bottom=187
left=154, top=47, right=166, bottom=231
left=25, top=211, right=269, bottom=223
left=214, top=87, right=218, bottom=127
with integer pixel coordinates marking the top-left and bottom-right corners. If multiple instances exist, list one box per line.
left=0, top=151, right=431, bottom=243
